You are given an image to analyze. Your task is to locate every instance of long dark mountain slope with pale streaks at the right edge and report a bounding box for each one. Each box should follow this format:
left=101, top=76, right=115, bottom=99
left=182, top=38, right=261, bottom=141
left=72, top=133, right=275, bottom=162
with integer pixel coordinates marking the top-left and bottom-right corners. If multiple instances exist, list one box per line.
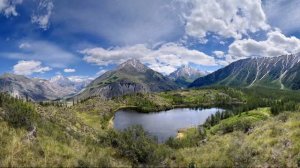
left=190, top=54, right=300, bottom=90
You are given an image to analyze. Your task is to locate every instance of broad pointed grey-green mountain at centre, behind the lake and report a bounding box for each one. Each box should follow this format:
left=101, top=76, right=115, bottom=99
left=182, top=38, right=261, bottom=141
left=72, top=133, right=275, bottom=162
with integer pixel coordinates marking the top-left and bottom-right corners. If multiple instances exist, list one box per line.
left=77, top=59, right=178, bottom=99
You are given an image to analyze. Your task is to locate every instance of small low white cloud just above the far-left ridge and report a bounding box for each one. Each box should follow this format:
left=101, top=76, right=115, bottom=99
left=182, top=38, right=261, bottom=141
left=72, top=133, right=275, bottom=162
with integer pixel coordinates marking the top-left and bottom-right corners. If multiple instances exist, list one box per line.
left=13, top=60, right=52, bottom=75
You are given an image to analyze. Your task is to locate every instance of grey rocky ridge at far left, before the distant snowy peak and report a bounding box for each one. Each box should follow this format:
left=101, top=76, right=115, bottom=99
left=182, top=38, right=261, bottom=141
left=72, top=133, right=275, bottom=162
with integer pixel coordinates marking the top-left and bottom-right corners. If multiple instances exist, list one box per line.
left=0, top=74, right=76, bottom=101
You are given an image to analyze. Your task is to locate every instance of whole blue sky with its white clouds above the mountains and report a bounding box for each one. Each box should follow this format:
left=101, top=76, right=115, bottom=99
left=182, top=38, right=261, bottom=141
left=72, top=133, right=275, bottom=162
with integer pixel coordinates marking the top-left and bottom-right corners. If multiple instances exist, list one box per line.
left=0, top=0, right=300, bottom=78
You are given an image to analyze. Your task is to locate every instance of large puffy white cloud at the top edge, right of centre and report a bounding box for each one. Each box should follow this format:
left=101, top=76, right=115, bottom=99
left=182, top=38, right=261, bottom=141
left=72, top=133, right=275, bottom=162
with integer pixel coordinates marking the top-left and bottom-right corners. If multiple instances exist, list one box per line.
left=186, top=0, right=269, bottom=39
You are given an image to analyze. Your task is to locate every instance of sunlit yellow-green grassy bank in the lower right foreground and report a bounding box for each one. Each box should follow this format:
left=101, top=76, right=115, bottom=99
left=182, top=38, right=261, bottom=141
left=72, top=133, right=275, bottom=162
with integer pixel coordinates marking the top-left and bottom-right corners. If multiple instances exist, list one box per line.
left=172, top=109, right=300, bottom=167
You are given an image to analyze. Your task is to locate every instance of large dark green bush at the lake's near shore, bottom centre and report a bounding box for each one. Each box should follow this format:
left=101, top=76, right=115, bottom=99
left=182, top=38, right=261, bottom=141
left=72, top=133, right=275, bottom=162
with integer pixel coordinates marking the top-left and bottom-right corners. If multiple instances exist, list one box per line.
left=102, top=126, right=169, bottom=165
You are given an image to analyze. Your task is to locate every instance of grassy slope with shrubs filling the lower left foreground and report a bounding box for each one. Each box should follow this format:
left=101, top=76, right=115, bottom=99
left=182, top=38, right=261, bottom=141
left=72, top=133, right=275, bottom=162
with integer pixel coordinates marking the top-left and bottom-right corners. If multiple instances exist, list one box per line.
left=0, top=92, right=131, bottom=167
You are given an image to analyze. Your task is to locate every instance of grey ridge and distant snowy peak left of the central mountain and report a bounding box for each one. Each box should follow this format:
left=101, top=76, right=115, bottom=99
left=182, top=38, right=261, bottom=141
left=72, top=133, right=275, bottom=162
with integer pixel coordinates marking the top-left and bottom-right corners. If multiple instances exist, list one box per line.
left=0, top=73, right=89, bottom=101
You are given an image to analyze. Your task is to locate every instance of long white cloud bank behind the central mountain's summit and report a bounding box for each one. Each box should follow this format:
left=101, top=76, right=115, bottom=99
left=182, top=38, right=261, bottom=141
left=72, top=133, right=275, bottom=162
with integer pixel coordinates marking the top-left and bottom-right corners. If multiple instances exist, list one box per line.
left=81, top=43, right=216, bottom=74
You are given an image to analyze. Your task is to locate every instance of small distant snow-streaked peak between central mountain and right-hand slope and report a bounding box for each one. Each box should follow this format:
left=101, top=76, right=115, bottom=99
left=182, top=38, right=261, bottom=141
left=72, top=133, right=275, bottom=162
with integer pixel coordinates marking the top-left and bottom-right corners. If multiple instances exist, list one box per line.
left=169, top=65, right=206, bottom=87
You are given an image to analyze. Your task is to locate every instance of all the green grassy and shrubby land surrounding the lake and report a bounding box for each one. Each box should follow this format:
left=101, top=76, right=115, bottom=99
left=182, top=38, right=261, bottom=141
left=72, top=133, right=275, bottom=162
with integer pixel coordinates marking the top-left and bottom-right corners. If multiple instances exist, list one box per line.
left=0, top=88, right=300, bottom=167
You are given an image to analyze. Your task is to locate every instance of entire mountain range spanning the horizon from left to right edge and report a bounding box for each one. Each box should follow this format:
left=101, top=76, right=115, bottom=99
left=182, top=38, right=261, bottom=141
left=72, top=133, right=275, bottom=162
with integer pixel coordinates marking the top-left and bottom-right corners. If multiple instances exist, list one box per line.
left=0, top=54, right=300, bottom=101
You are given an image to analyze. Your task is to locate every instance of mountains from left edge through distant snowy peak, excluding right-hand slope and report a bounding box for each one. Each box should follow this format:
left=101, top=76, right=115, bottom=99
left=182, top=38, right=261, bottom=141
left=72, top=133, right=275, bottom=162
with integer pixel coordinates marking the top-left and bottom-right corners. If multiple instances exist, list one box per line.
left=0, top=59, right=197, bottom=101
